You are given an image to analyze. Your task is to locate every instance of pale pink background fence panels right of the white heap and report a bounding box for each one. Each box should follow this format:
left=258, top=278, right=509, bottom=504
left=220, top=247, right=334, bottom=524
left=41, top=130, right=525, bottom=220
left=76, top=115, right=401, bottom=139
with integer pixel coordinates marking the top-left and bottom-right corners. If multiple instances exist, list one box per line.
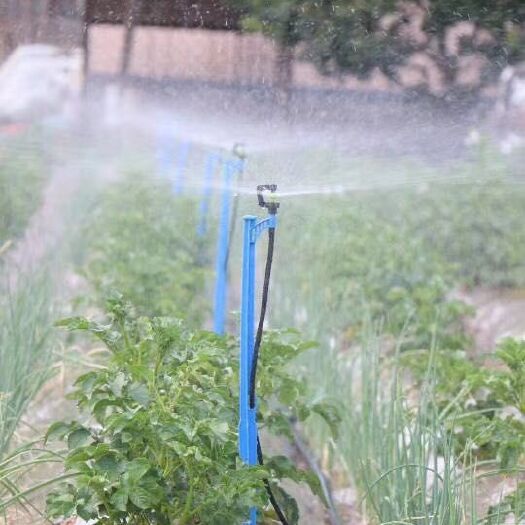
left=89, top=24, right=390, bottom=90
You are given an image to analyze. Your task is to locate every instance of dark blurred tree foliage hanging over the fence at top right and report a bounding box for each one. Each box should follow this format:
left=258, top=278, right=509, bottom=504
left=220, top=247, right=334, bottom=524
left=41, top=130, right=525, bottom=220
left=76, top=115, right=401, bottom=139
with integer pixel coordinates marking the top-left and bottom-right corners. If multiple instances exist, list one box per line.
left=232, top=0, right=525, bottom=96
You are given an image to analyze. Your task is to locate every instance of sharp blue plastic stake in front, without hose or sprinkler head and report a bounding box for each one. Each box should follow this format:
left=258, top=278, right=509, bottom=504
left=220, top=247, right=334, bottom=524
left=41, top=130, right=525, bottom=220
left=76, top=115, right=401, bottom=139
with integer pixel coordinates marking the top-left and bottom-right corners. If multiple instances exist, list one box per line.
left=239, top=211, right=277, bottom=525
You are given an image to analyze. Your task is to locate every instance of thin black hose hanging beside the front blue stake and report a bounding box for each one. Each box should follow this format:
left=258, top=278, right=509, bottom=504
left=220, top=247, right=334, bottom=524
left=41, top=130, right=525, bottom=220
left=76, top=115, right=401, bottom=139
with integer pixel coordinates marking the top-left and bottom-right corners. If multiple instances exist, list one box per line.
left=246, top=228, right=289, bottom=525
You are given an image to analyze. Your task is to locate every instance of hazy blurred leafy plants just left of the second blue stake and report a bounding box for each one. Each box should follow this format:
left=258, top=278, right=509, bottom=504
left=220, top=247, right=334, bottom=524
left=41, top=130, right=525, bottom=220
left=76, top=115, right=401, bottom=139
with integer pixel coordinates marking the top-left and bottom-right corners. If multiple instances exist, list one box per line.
left=85, top=173, right=207, bottom=326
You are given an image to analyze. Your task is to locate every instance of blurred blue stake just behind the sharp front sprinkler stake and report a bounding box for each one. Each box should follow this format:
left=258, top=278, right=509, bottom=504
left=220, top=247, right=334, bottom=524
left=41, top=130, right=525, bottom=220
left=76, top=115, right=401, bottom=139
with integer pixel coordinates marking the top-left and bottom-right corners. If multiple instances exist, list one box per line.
left=213, top=160, right=234, bottom=335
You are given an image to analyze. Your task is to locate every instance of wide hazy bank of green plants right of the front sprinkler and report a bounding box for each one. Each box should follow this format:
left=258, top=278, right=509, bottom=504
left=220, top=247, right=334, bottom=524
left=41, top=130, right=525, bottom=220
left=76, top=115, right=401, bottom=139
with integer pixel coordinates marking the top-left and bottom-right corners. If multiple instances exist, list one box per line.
left=270, top=151, right=525, bottom=350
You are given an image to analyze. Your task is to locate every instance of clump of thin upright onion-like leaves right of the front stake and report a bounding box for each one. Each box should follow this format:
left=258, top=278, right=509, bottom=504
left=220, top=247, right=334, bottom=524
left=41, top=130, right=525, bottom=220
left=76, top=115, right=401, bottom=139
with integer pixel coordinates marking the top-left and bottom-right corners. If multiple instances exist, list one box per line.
left=302, top=330, right=476, bottom=525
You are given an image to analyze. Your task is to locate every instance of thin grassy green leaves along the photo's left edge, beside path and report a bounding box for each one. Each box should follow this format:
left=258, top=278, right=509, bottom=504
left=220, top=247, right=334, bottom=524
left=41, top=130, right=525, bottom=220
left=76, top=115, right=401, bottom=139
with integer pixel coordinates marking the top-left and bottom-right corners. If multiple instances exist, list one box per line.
left=0, top=268, right=59, bottom=519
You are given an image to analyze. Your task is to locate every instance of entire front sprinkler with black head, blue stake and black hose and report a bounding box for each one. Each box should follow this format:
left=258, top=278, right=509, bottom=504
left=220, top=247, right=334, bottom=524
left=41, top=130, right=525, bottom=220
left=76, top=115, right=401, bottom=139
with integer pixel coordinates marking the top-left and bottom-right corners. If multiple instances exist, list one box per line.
left=239, top=184, right=288, bottom=525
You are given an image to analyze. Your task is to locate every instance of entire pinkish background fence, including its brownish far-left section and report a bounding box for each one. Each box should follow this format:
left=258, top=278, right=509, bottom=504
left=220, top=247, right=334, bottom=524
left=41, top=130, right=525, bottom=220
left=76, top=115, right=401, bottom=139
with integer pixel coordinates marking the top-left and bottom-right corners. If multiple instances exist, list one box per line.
left=0, top=0, right=392, bottom=90
